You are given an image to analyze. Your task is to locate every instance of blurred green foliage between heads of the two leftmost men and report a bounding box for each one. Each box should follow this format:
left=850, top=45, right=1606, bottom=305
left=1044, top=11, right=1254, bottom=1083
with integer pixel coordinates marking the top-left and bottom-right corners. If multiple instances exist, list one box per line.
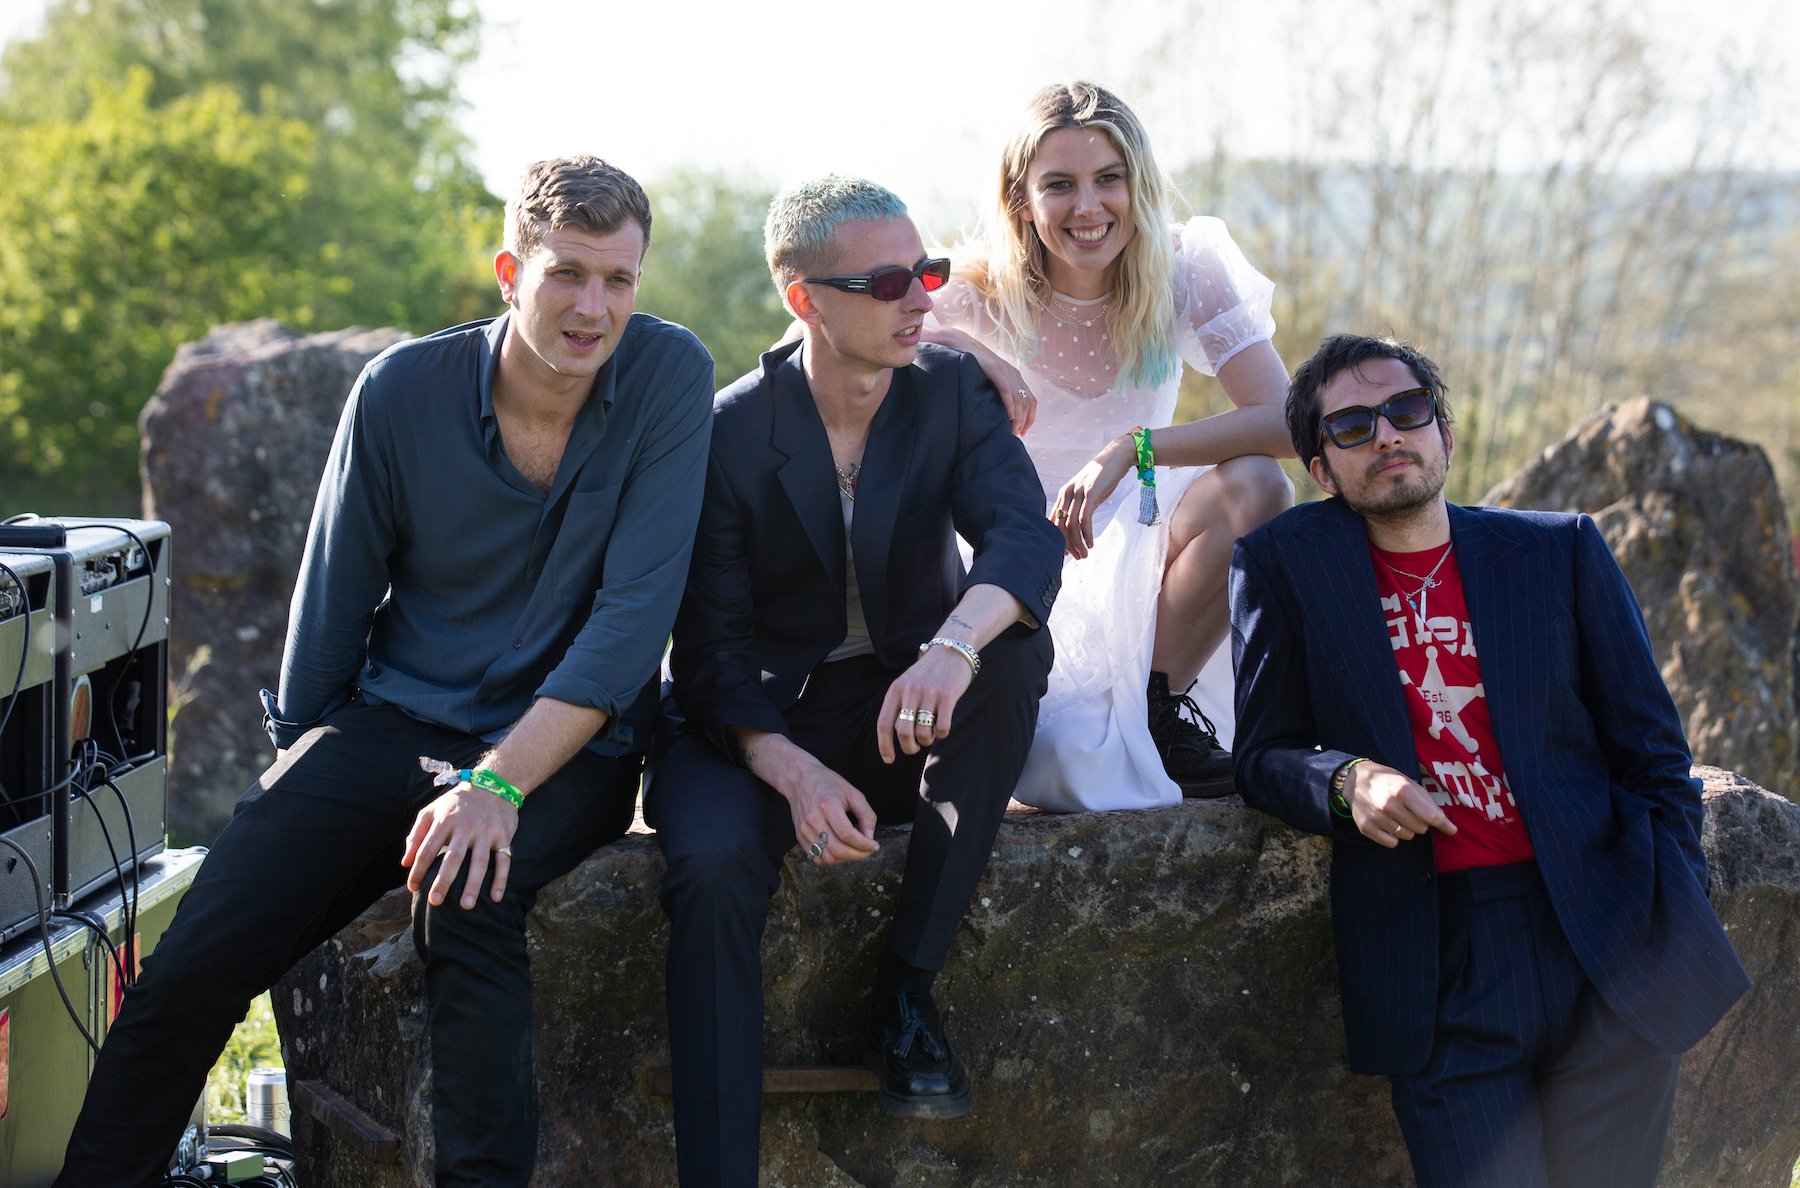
left=637, top=169, right=788, bottom=387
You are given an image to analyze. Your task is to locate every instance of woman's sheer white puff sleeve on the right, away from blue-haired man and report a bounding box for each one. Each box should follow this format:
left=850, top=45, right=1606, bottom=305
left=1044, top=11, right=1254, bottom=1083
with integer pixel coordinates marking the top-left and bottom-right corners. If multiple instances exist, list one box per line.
left=1175, top=214, right=1274, bottom=376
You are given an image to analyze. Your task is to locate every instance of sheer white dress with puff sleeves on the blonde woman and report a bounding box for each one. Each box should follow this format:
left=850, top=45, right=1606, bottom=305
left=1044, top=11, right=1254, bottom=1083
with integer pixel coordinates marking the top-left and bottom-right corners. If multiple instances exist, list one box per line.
left=932, top=218, right=1274, bottom=812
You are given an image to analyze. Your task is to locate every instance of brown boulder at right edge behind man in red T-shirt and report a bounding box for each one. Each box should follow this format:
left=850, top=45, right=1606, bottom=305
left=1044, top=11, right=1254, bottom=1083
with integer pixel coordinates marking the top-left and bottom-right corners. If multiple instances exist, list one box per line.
left=1483, top=398, right=1800, bottom=801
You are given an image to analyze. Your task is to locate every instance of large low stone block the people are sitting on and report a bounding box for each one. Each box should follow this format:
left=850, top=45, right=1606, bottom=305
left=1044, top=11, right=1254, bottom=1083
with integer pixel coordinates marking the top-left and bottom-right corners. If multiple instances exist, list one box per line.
left=275, top=769, right=1800, bottom=1188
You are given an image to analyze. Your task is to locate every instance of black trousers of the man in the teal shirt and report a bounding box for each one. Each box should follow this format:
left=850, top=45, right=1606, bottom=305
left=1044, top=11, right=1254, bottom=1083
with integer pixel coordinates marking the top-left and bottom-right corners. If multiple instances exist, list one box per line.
left=56, top=702, right=641, bottom=1188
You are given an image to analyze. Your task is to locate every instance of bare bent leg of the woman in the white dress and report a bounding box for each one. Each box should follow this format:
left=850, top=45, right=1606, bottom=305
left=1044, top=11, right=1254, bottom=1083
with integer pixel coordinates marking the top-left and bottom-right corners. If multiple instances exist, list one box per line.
left=1150, top=454, right=1294, bottom=693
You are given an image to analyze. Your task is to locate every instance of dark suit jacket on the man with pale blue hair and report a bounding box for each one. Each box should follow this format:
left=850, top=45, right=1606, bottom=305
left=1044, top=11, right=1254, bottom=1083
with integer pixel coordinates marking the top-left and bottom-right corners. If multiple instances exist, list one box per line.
left=670, top=344, right=1062, bottom=734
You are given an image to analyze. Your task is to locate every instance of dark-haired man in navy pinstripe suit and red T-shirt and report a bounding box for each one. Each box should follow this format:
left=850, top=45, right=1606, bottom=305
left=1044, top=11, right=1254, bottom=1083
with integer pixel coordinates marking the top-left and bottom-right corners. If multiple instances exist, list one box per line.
left=1231, top=335, right=1748, bottom=1188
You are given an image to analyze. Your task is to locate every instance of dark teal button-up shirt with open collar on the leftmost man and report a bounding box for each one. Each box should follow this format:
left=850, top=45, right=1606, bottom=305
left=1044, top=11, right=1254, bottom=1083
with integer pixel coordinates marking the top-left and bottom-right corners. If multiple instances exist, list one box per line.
left=263, top=313, right=713, bottom=754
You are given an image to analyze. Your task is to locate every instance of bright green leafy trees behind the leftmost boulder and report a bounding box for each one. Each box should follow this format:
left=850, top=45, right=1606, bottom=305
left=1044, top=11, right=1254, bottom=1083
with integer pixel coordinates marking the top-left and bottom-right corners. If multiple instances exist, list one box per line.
left=0, top=0, right=499, bottom=511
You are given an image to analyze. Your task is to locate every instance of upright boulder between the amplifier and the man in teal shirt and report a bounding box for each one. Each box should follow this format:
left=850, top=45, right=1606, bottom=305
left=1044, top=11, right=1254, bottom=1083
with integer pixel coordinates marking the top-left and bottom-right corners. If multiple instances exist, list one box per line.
left=140, top=319, right=407, bottom=842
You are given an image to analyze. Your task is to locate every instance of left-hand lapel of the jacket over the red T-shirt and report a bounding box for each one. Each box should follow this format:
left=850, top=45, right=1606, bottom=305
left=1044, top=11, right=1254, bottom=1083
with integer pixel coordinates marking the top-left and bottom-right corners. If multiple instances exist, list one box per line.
left=1296, top=499, right=1418, bottom=774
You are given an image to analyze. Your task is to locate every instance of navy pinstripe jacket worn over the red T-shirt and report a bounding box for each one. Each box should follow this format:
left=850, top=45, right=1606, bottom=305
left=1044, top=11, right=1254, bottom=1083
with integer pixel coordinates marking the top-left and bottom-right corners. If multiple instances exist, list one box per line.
left=1231, top=499, right=1750, bottom=1073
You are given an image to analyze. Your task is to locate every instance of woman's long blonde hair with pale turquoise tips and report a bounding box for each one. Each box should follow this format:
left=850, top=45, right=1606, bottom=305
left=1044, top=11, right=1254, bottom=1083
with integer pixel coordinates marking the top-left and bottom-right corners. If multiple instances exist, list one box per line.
left=965, top=83, right=1181, bottom=387
